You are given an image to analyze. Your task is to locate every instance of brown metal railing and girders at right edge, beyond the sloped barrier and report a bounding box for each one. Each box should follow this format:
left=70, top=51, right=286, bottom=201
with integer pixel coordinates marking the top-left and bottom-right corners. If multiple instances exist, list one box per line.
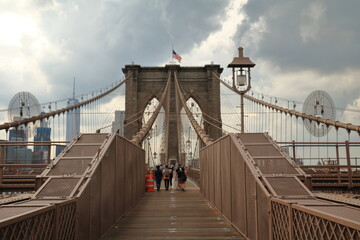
left=278, top=141, right=360, bottom=190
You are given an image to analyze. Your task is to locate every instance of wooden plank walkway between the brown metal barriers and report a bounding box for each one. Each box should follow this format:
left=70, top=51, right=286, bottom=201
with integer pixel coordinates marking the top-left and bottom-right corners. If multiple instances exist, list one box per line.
left=104, top=182, right=245, bottom=240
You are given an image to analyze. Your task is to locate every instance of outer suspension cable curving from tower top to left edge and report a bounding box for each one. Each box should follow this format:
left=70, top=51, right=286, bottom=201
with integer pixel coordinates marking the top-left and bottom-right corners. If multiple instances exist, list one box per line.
left=0, top=73, right=132, bottom=130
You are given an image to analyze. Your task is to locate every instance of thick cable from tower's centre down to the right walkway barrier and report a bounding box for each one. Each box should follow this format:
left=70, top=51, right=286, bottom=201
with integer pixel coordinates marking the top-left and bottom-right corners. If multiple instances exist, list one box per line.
left=174, top=71, right=213, bottom=146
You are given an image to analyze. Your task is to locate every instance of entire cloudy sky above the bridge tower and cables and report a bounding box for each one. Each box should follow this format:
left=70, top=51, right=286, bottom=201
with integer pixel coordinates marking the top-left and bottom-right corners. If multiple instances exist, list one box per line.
left=0, top=0, right=360, bottom=124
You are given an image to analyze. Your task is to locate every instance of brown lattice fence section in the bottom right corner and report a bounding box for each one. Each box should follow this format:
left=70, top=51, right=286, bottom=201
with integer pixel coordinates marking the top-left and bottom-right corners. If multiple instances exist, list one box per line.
left=271, top=199, right=360, bottom=240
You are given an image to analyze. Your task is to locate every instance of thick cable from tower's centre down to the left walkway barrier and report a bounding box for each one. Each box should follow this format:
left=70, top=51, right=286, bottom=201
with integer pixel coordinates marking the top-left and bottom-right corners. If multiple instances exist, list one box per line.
left=131, top=71, right=171, bottom=145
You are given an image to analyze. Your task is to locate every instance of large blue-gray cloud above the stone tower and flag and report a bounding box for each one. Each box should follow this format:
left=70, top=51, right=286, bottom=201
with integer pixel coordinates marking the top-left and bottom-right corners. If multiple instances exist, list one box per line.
left=0, top=0, right=229, bottom=109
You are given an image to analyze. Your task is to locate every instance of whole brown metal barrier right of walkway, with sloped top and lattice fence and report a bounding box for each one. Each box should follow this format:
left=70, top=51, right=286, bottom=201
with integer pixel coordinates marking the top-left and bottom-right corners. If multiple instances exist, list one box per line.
left=200, top=134, right=360, bottom=240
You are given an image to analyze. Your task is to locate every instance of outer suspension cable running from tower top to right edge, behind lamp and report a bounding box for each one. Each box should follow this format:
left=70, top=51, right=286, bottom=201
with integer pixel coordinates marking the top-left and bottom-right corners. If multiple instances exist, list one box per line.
left=212, top=72, right=360, bottom=134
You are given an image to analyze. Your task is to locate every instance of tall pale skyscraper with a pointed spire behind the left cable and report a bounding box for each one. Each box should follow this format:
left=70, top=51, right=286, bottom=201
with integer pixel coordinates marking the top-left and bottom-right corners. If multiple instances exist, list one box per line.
left=66, top=79, right=80, bottom=142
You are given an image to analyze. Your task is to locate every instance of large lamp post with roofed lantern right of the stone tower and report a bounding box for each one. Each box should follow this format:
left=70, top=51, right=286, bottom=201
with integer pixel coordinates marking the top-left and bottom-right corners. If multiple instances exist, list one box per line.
left=228, top=47, right=255, bottom=133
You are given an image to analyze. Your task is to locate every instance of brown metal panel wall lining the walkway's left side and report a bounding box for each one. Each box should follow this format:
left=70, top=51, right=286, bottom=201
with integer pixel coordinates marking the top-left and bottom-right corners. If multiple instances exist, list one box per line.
left=76, top=136, right=145, bottom=239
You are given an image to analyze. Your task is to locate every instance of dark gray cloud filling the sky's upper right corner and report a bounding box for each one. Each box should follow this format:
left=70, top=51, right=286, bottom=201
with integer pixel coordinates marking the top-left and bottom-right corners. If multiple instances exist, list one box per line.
left=236, top=0, right=360, bottom=72
